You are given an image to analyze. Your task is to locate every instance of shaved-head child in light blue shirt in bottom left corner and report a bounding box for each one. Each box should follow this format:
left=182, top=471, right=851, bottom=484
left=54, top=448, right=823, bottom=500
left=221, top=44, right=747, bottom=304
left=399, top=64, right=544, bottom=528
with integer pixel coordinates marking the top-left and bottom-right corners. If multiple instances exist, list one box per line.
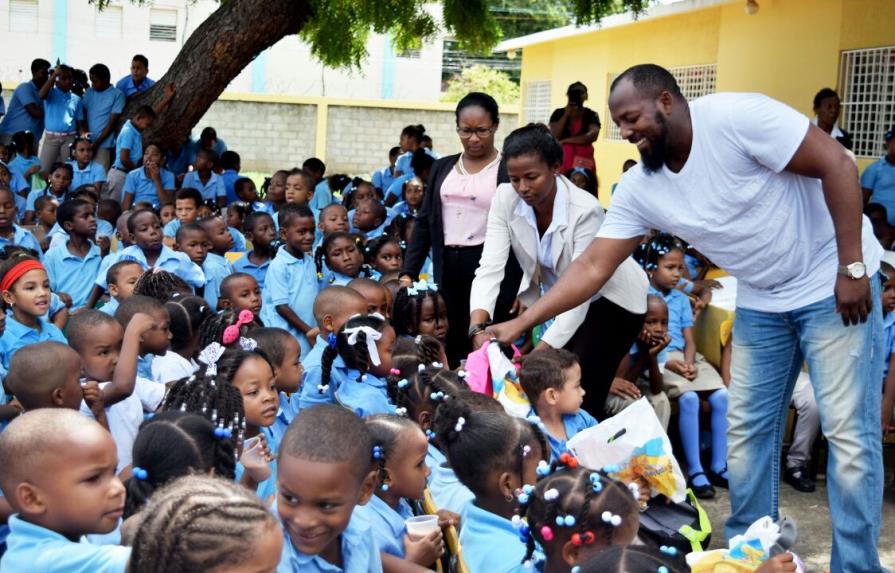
left=0, top=408, right=131, bottom=573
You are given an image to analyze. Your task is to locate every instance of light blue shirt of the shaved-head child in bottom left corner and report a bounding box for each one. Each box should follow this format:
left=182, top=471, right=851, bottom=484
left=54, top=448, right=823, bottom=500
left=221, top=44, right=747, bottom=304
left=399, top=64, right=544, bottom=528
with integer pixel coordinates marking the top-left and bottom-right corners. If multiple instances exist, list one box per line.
left=0, top=514, right=131, bottom=573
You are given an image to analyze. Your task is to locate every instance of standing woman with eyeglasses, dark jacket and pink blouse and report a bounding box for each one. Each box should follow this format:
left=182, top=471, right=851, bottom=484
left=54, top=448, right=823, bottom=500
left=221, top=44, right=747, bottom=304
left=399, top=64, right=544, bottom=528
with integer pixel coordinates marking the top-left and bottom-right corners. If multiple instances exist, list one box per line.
left=401, top=92, right=522, bottom=366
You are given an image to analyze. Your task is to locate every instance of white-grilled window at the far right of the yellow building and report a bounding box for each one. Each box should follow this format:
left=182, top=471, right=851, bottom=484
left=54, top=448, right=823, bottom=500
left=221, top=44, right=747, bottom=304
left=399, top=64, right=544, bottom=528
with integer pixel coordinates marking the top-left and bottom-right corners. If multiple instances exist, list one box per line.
left=839, top=46, right=895, bottom=157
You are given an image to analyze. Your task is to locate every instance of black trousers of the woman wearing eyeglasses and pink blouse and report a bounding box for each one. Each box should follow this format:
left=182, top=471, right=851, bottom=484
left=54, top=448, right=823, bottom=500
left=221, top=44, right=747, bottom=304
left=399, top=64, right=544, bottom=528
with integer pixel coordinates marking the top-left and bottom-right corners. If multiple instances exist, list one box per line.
left=438, top=245, right=522, bottom=368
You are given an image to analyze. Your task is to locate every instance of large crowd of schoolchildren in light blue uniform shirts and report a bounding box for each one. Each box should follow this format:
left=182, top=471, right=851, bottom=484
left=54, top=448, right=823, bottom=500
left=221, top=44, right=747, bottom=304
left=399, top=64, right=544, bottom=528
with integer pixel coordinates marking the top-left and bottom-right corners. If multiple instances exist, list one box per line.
left=0, top=57, right=880, bottom=573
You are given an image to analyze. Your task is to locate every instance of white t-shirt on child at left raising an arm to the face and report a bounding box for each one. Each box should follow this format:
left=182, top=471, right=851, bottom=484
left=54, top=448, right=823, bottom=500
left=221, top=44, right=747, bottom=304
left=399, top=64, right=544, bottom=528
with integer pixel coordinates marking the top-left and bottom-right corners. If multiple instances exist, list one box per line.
left=81, top=376, right=165, bottom=473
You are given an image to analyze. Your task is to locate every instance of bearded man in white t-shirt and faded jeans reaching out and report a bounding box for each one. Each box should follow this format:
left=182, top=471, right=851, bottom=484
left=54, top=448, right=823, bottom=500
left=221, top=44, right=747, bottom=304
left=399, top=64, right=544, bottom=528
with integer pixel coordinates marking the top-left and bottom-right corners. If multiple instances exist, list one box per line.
left=489, top=64, right=883, bottom=573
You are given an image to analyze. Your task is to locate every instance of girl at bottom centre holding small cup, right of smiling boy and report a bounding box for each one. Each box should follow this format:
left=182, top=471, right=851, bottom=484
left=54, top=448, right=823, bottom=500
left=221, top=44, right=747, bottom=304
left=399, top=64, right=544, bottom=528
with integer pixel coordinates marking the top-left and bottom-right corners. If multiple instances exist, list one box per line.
left=355, top=414, right=448, bottom=567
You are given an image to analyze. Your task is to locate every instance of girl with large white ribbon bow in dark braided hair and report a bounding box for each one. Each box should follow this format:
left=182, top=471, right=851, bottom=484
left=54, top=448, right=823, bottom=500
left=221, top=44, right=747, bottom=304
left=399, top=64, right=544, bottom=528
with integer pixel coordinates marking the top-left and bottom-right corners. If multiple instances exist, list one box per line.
left=317, top=315, right=395, bottom=417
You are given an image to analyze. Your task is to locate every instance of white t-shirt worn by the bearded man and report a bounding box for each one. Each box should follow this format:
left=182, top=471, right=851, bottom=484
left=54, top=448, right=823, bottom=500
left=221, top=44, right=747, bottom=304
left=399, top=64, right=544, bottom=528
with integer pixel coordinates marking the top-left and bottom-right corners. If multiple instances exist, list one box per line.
left=597, top=93, right=882, bottom=312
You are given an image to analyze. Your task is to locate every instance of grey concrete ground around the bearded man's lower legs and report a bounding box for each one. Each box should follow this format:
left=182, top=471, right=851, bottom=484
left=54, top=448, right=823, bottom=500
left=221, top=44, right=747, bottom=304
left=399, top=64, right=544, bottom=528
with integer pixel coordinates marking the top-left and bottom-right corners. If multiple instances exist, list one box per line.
left=701, top=448, right=895, bottom=573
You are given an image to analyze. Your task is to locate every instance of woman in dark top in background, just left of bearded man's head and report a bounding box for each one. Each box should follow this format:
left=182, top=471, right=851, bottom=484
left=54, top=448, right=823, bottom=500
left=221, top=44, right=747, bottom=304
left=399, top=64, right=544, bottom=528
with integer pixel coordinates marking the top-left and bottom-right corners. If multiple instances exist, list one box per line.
left=550, top=82, right=600, bottom=173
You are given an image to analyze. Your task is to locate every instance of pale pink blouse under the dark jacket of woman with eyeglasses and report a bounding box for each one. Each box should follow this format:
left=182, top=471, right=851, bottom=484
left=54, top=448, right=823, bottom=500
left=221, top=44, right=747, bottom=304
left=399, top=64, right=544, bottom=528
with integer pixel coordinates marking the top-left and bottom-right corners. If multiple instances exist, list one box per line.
left=441, top=154, right=500, bottom=247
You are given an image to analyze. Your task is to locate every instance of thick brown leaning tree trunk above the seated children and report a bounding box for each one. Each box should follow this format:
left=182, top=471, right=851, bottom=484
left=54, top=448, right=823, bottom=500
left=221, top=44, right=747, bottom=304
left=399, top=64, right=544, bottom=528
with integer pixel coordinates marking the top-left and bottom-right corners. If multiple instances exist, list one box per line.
left=128, top=0, right=311, bottom=149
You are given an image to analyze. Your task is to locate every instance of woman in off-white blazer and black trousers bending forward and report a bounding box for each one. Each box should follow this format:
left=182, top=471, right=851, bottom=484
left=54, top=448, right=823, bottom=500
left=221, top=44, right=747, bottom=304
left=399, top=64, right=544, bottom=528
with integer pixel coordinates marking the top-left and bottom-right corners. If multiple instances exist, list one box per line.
left=469, top=124, right=648, bottom=416
